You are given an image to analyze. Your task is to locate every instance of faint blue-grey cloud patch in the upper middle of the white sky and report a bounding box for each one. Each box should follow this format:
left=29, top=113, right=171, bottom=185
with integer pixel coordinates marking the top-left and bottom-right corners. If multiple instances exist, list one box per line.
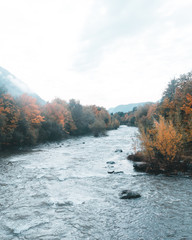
left=74, top=0, right=162, bottom=71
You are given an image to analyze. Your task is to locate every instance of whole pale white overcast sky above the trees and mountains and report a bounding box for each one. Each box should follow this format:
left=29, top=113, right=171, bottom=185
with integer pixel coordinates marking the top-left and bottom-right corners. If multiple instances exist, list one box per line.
left=0, top=0, right=192, bottom=108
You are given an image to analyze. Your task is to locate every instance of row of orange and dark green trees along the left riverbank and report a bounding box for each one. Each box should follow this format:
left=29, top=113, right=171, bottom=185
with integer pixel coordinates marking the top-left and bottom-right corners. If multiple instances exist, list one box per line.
left=0, top=88, right=119, bottom=149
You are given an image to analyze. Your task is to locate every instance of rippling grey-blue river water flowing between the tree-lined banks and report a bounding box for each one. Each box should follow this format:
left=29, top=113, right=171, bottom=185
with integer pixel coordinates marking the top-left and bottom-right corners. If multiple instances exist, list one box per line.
left=0, top=126, right=192, bottom=240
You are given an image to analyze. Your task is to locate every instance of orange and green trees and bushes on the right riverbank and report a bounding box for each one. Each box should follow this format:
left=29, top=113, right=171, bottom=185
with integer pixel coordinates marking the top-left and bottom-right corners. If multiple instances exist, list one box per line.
left=114, top=72, right=192, bottom=174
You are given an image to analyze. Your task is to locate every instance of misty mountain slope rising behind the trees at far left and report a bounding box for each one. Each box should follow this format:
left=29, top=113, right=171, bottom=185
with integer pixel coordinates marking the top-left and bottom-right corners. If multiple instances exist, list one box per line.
left=0, top=67, right=45, bottom=104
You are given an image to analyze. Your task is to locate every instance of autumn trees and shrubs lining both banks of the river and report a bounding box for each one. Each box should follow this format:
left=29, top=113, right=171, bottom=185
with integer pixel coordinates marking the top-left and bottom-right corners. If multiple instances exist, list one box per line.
left=0, top=72, right=192, bottom=173
